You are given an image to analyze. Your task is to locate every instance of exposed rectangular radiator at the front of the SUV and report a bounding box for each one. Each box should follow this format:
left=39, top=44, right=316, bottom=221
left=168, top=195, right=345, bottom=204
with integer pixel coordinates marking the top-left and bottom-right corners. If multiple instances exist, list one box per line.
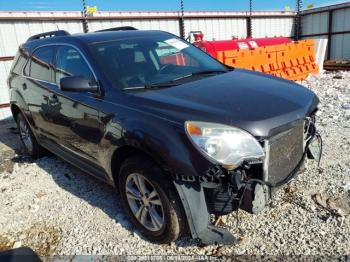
left=265, top=121, right=304, bottom=184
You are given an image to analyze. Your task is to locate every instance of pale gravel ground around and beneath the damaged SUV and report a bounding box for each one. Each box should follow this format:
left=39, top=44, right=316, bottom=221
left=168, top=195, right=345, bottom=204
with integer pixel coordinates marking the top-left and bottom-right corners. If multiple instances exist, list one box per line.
left=0, top=72, right=350, bottom=257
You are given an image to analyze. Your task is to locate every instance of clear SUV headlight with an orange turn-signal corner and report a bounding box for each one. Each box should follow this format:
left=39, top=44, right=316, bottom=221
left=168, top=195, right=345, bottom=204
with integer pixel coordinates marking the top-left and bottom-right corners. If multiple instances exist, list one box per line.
left=185, top=121, right=265, bottom=168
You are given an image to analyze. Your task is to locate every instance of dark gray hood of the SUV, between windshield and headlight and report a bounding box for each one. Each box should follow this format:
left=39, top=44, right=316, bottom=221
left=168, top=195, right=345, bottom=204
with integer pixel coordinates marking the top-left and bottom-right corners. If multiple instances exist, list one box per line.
left=131, top=69, right=319, bottom=137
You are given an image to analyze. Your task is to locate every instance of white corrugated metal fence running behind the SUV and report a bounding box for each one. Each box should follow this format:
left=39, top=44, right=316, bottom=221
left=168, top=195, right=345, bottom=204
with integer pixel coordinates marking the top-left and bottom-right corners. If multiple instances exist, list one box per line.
left=0, top=12, right=294, bottom=119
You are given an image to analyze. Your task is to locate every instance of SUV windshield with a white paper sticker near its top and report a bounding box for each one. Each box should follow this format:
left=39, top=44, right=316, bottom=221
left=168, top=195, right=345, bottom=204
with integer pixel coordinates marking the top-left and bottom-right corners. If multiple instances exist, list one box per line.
left=91, top=33, right=227, bottom=89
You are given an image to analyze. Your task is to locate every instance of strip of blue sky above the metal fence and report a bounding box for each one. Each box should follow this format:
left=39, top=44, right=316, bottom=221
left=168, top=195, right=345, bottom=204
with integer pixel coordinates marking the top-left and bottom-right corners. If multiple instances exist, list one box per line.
left=0, top=0, right=349, bottom=11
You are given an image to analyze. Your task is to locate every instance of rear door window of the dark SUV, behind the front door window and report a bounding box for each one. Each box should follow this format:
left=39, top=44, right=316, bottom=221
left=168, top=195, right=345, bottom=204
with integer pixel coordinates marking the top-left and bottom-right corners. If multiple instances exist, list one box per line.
left=24, top=46, right=54, bottom=82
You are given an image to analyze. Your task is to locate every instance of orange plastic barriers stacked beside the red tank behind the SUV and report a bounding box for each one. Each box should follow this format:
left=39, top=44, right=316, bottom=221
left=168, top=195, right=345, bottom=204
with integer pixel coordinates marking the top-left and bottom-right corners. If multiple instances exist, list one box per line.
left=217, top=40, right=319, bottom=81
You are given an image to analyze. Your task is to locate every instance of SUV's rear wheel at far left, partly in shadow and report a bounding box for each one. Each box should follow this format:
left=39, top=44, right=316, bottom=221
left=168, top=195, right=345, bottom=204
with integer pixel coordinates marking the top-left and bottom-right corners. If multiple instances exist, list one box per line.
left=16, top=113, right=46, bottom=158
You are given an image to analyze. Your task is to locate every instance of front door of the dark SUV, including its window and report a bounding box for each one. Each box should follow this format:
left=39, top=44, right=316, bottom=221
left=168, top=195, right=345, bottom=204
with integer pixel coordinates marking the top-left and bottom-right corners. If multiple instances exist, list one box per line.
left=47, top=45, right=102, bottom=164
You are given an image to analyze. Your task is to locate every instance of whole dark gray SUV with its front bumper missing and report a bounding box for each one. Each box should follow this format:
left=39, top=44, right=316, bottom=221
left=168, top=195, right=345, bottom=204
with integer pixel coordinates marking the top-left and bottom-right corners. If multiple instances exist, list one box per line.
left=8, top=28, right=320, bottom=244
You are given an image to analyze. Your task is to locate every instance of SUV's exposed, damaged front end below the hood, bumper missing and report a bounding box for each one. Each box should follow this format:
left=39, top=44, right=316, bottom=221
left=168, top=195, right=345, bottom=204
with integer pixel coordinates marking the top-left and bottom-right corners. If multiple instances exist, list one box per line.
left=173, top=116, right=322, bottom=245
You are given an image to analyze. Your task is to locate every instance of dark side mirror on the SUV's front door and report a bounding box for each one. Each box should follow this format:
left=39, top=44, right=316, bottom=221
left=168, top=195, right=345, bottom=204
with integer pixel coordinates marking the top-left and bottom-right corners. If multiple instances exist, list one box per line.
left=60, top=76, right=98, bottom=92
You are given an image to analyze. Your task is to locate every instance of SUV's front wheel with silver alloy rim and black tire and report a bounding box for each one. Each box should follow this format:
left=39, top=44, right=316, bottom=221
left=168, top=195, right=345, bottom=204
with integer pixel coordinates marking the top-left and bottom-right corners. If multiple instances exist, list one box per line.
left=119, top=156, right=187, bottom=244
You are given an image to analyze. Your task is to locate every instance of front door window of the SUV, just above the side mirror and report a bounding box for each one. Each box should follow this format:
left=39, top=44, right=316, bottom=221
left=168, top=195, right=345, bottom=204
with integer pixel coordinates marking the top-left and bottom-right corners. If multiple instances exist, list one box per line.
left=55, top=46, right=94, bottom=83
